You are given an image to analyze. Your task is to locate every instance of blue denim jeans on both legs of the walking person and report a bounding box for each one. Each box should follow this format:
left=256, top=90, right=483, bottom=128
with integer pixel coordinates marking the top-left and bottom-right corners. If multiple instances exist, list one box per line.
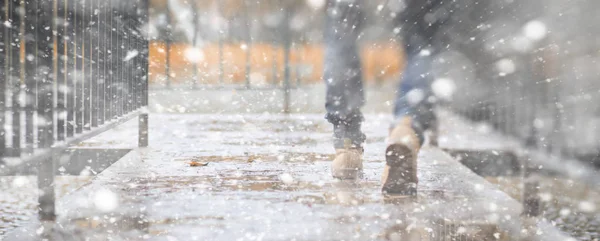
left=323, top=0, right=436, bottom=148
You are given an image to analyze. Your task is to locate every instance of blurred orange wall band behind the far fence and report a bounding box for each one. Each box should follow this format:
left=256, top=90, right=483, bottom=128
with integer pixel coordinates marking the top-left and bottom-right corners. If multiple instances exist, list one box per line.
left=150, top=42, right=404, bottom=84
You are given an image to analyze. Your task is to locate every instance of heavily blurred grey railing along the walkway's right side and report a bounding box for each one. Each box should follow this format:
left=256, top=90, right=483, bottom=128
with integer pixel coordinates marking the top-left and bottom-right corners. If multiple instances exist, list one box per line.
left=436, top=0, right=600, bottom=164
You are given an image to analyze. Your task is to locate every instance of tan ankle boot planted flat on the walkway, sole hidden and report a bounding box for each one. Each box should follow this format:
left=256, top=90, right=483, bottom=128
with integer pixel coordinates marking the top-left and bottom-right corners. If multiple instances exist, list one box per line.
left=331, top=139, right=363, bottom=180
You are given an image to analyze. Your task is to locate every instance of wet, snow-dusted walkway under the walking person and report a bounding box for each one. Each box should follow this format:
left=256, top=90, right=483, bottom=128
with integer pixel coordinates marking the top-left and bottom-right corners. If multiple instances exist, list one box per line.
left=7, top=114, right=568, bottom=240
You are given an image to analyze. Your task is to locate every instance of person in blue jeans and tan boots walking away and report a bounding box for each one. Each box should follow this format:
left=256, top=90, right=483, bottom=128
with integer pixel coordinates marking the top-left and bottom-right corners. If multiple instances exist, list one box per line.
left=323, top=0, right=448, bottom=196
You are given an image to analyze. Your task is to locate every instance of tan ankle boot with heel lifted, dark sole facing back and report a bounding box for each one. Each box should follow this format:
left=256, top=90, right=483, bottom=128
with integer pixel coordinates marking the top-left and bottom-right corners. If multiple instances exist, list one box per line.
left=381, top=118, right=421, bottom=196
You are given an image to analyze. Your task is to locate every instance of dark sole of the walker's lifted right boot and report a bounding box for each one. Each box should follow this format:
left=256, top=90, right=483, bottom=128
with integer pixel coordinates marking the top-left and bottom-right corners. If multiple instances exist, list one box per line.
left=381, top=144, right=417, bottom=196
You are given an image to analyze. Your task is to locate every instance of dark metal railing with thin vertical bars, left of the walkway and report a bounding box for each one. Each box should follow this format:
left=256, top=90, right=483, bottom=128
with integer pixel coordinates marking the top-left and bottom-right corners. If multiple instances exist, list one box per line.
left=0, top=0, right=149, bottom=220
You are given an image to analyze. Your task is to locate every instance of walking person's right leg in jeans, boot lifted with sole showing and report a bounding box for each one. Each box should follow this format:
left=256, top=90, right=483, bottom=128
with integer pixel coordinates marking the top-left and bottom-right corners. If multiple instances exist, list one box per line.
left=382, top=1, right=441, bottom=196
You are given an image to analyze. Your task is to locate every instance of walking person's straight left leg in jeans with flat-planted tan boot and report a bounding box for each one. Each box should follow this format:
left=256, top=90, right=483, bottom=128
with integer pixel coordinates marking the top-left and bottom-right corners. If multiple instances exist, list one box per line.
left=323, top=0, right=365, bottom=179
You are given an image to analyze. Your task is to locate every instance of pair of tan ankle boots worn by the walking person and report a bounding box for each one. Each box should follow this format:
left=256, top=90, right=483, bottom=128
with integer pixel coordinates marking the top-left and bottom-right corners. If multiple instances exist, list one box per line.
left=331, top=117, right=422, bottom=196
